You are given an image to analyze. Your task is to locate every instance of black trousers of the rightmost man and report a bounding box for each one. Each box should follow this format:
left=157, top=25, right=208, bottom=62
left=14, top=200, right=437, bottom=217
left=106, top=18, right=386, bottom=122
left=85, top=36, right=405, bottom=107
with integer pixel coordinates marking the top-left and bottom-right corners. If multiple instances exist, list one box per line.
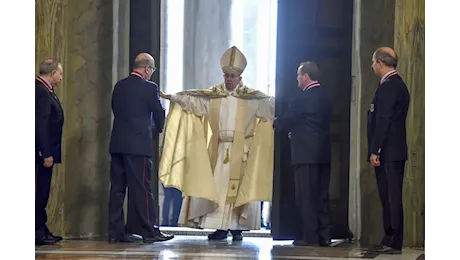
left=374, top=161, right=406, bottom=249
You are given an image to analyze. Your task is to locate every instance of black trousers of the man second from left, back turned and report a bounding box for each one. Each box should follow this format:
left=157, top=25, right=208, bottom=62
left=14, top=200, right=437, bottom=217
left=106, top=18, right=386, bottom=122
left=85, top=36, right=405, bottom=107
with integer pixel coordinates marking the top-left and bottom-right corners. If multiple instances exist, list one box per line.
left=109, top=154, right=157, bottom=237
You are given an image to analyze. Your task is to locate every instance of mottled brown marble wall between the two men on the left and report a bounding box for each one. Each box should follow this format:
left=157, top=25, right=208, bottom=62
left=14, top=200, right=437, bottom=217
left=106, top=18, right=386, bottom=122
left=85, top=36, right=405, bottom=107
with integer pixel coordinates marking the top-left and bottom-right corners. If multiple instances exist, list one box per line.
left=34, top=0, right=128, bottom=238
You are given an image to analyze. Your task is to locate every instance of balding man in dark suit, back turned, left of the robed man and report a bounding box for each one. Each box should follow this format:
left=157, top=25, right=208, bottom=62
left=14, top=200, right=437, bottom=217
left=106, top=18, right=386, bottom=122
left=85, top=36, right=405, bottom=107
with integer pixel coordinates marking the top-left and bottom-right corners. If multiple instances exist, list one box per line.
left=109, top=53, right=173, bottom=243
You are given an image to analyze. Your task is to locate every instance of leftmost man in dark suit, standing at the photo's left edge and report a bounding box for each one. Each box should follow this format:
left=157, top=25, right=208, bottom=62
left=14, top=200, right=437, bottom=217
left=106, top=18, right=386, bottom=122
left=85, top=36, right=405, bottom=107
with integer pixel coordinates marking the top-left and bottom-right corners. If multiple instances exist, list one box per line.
left=32, top=59, right=64, bottom=245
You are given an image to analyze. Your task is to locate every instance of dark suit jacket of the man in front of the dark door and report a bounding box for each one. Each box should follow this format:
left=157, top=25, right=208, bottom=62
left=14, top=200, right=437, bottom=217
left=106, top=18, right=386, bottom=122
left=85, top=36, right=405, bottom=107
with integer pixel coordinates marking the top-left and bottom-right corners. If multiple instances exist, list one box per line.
left=274, top=86, right=332, bottom=165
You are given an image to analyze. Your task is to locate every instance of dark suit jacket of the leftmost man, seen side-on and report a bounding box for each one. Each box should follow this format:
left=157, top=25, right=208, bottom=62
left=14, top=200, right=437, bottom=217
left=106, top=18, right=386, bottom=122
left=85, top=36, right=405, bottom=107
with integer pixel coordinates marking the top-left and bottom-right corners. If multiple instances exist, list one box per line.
left=32, top=80, right=64, bottom=163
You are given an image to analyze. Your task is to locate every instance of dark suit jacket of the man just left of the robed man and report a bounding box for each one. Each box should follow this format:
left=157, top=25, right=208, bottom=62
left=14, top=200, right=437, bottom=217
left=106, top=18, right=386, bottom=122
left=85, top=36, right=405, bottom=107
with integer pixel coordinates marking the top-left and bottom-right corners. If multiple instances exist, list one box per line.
left=109, top=75, right=165, bottom=156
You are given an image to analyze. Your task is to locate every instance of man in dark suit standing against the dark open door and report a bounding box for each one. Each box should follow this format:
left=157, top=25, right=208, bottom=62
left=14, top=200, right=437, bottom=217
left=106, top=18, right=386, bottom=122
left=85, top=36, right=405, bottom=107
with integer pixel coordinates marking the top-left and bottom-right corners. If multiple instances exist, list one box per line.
left=274, top=61, right=332, bottom=246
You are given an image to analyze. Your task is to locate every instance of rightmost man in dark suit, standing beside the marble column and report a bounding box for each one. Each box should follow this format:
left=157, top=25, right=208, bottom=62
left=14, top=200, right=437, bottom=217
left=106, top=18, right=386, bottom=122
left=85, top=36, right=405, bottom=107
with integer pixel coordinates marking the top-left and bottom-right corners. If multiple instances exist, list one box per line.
left=367, top=47, right=410, bottom=253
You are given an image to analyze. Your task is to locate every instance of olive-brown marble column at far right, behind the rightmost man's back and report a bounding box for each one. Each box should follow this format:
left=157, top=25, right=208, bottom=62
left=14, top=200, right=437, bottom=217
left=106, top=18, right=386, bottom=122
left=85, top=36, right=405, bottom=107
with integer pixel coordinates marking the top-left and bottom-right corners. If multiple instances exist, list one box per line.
left=394, top=0, right=426, bottom=247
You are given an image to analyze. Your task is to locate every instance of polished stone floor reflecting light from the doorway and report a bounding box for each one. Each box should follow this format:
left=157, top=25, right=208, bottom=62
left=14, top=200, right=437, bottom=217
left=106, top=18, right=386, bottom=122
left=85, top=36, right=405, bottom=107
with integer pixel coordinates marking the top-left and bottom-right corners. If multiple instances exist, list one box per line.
left=35, top=235, right=427, bottom=260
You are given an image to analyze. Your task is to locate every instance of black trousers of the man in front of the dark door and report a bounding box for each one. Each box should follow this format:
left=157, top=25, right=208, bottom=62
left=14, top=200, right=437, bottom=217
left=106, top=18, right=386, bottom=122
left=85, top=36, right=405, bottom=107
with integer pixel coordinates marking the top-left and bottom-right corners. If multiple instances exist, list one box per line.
left=294, top=163, right=332, bottom=244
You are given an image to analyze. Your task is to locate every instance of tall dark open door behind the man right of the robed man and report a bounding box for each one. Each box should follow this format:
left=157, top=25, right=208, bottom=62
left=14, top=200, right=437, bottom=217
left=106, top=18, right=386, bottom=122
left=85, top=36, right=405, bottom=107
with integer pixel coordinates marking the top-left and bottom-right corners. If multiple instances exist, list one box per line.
left=271, top=0, right=353, bottom=240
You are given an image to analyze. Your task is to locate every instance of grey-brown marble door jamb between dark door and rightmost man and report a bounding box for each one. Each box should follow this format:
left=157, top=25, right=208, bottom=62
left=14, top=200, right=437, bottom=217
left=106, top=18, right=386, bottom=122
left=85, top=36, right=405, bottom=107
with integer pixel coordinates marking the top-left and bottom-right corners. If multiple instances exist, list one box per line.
left=349, top=0, right=394, bottom=244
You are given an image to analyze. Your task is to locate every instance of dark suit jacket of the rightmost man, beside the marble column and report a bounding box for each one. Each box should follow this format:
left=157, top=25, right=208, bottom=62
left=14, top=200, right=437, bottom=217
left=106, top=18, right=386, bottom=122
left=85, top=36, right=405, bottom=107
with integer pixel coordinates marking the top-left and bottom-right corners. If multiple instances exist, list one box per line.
left=367, top=75, right=410, bottom=162
